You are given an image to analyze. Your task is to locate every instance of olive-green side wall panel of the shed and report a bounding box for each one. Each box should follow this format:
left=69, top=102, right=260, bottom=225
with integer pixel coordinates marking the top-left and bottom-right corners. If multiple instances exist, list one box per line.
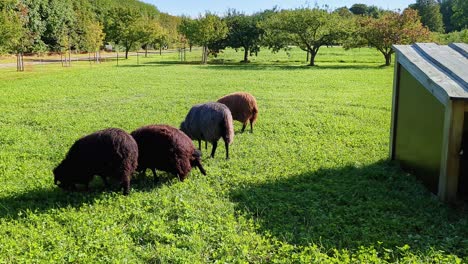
left=395, top=66, right=445, bottom=193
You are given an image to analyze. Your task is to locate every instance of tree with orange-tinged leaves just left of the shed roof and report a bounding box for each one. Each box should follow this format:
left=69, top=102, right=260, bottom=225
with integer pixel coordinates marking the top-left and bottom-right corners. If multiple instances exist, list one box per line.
left=352, top=8, right=430, bottom=66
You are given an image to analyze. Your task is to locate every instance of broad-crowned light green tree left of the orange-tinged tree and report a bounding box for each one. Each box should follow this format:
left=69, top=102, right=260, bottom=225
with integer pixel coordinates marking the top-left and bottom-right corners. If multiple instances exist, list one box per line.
left=262, top=8, right=348, bottom=66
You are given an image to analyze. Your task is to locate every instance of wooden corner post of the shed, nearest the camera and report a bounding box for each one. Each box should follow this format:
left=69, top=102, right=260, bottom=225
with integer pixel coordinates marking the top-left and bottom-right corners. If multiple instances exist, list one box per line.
left=438, top=101, right=465, bottom=202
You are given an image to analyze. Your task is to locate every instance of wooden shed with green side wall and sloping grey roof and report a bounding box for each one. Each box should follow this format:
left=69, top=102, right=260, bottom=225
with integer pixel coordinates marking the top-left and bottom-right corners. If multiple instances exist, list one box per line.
left=390, top=43, right=468, bottom=201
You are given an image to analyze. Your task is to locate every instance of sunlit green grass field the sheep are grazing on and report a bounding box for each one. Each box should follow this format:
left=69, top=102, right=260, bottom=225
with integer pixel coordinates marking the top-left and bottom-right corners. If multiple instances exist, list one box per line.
left=0, top=48, right=468, bottom=263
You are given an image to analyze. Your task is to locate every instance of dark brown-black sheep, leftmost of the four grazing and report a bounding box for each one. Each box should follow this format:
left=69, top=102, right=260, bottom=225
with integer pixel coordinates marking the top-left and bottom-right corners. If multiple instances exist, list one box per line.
left=54, top=128, right=138, bottom=195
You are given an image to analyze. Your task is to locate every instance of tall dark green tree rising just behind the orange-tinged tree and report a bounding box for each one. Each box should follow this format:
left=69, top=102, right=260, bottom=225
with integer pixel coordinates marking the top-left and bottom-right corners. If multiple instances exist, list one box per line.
left=409, top=0, right=444, bottom=32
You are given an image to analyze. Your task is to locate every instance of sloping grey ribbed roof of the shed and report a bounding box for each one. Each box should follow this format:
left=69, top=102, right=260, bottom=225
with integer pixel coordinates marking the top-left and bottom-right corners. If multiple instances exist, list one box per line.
left=393, top=43, right=468, bottom=105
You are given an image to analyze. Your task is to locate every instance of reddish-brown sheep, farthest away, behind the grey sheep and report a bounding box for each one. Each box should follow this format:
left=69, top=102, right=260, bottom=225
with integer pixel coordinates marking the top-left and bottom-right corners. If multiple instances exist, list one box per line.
left=218, top=92, right=258, bottom=133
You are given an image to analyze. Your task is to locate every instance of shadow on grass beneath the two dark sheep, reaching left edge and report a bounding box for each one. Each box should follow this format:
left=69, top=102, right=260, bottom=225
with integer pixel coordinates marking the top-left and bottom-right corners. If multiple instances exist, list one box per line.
left=0, top=172, right=173, bottom=219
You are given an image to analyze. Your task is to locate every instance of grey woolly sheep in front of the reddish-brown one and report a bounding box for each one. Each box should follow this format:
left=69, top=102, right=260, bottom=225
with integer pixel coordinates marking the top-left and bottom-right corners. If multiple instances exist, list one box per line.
left=180, top=102, right=234, bottom=159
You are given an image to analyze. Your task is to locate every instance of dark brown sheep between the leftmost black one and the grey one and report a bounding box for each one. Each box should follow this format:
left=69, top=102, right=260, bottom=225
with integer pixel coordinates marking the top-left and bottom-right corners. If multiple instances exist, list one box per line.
left=131, top=125, right=206, bottom=181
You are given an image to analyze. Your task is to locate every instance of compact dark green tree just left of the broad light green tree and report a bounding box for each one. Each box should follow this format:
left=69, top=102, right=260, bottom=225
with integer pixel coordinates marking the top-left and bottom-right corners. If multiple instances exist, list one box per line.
left=225, top=10, right=264, bottom=63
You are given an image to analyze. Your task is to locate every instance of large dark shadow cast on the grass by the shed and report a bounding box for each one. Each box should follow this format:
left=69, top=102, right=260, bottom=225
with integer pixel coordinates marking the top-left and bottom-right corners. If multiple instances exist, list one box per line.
left=231, top=161, right=468, bottom=256
